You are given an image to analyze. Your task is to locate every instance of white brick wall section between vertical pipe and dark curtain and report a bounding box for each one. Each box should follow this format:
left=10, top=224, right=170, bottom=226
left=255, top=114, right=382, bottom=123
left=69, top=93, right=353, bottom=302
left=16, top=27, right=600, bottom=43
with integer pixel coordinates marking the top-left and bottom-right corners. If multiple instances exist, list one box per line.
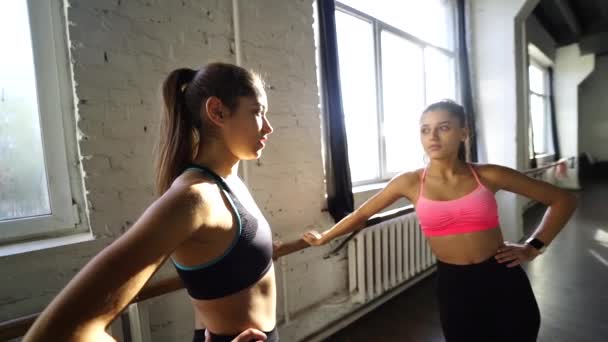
left=239, top=0, right=347, bottom=328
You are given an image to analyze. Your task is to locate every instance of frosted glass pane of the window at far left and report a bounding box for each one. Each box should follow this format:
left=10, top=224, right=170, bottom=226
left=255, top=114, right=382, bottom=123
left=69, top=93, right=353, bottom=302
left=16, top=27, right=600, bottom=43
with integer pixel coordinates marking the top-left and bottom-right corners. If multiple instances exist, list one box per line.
left=0, top=1, right=51, bottom=220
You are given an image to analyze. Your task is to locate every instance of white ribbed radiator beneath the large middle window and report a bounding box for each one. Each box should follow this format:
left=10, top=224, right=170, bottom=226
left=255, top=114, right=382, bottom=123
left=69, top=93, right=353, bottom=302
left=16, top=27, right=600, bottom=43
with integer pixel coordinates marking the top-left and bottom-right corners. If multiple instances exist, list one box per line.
left=348, top=212, right=436, bottom=303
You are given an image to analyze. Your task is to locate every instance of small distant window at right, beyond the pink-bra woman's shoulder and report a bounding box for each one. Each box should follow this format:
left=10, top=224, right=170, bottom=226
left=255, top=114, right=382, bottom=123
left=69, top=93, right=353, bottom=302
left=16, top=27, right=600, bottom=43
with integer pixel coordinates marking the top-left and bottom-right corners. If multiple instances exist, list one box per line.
left=528, top=57, right=553, bottom=158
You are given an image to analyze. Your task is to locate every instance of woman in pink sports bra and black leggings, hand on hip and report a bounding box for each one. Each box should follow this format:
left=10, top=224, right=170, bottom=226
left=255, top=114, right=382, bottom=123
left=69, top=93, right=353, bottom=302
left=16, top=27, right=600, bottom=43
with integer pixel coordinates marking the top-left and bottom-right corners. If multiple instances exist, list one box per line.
left=303, top=100, right=576, bottom=342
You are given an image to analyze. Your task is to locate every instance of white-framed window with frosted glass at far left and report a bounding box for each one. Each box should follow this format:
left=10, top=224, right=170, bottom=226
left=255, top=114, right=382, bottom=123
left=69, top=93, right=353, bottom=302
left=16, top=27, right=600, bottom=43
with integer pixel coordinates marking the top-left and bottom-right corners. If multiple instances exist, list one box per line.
left=0, top=0, right=78, bottom=243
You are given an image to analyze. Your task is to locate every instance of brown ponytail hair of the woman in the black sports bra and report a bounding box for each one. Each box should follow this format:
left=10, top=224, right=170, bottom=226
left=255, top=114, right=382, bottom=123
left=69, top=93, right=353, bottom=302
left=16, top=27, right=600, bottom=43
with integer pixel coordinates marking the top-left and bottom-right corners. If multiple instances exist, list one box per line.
left=156, top=63, right=262, bottom=195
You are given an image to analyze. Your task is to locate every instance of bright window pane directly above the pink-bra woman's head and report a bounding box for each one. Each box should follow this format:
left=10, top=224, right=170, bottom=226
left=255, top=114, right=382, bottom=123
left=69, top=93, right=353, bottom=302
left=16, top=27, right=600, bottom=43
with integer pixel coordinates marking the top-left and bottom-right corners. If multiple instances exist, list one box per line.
left=424, top=48, right=456, bottom=105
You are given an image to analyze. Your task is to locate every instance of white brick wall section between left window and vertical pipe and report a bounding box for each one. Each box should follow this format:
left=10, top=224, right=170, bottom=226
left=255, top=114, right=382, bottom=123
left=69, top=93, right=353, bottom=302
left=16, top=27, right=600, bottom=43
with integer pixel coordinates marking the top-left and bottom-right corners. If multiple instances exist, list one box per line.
left=0, top=1, right=234, bottom=340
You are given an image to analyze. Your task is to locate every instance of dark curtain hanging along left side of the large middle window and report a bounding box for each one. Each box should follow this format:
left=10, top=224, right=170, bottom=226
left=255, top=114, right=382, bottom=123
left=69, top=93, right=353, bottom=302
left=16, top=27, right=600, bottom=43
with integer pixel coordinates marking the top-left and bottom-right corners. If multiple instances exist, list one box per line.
left=317, top=0, right=354, bottom=222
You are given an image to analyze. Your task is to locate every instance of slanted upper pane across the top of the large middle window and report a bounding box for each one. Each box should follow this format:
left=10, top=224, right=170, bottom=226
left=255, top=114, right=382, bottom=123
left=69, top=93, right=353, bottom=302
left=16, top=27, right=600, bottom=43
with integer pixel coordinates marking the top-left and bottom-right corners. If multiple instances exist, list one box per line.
left=339, top=0, right=453, bottom=50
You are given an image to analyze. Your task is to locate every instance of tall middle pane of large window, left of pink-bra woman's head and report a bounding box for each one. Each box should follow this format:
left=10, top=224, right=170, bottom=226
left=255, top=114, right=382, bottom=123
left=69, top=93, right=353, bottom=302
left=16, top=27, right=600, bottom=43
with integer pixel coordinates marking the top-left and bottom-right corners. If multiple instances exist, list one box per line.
left=381, top=31, right=424, bottom=173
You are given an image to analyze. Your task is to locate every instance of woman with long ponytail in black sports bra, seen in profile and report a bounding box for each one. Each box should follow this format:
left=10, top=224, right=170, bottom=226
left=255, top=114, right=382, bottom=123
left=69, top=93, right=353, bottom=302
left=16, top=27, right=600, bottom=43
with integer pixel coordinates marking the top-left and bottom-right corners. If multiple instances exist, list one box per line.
left=24, top=63, right=278, bottom=341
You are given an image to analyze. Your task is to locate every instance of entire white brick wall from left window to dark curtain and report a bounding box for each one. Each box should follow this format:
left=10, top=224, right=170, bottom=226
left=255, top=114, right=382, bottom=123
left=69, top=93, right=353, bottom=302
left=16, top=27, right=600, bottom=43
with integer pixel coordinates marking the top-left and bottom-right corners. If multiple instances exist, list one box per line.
left=0, top=0, right=347, bottom=341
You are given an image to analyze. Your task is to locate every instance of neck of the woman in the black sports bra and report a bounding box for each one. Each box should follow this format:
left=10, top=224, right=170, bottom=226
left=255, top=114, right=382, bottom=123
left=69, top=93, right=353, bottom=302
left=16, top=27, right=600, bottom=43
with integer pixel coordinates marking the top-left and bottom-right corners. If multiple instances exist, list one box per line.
left=193, top=142, right=240, bottom=178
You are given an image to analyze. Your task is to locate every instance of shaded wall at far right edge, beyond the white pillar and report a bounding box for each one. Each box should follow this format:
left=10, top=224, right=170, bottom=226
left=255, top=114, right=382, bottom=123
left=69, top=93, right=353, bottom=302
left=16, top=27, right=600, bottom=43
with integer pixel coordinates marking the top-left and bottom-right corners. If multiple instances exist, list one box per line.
left=578, top=55, right=608, bottom=161
